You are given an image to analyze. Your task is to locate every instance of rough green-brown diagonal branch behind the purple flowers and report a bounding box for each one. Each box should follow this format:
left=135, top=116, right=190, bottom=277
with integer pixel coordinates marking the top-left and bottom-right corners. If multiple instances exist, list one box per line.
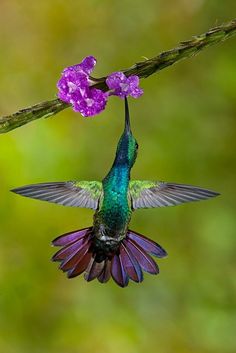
left=0, top=19, right=236, bottom=133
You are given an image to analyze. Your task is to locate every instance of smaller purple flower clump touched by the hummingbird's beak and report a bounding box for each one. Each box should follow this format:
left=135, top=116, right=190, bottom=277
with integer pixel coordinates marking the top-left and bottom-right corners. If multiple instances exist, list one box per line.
left=106, top=71, right=143, bottom=98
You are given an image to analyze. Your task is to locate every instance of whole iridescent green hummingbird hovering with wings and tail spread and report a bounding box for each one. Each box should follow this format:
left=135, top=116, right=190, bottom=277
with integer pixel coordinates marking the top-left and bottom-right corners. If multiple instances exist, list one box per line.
left=11, top=98, right=219, bottom=287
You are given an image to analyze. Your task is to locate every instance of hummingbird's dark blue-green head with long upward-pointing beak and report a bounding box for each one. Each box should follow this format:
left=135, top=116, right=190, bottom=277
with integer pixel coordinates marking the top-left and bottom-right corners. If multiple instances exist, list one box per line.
left=116, top=97, right=138, bottom=168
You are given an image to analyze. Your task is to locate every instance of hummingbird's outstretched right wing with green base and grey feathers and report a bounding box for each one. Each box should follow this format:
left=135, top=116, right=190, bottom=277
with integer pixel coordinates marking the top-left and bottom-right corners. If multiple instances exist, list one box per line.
left=129, top=180, right=219, bottom=209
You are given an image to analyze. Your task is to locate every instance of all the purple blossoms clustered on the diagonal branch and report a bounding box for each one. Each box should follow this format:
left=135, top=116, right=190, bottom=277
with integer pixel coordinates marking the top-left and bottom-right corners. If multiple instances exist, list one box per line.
left=57, top=56, right=143, bottom=116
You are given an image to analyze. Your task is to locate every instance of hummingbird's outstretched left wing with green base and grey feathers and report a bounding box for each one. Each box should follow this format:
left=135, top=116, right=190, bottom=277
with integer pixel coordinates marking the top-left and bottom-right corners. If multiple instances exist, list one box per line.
left=11, top=181, right=103, bottom=210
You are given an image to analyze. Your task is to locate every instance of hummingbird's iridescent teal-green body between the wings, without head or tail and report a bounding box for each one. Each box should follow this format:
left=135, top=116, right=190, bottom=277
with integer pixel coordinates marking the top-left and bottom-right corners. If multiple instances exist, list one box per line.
left=93, top=164, right=132, bottom=261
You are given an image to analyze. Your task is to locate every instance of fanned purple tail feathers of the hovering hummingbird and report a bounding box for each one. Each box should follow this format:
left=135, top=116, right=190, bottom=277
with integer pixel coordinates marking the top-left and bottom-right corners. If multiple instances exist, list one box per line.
left=52, top=227, right=167, bottom=287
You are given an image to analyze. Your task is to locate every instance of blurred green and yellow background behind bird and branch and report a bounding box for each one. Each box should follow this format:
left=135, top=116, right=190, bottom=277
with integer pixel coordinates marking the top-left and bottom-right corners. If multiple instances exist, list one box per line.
left=0, top=0, right=236, bottom=353
